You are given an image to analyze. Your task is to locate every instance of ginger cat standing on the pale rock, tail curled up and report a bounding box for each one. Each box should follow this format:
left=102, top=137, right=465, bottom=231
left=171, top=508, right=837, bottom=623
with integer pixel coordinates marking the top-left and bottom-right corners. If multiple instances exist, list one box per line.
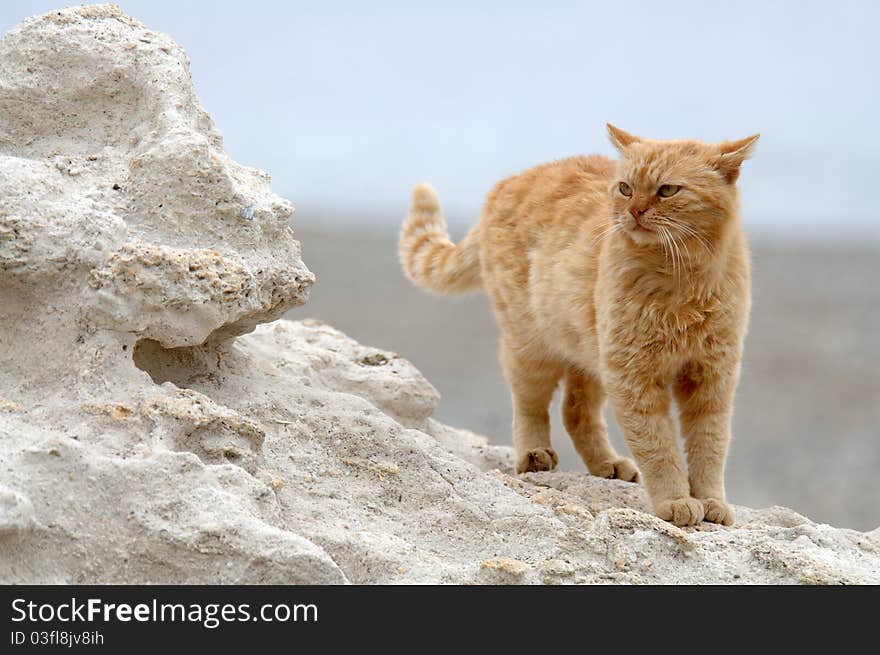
left=400, top=125, right=758, bottom=526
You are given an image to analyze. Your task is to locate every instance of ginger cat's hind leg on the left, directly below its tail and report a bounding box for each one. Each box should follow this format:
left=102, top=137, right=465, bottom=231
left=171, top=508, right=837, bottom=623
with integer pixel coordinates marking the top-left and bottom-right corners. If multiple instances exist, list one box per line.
left=501, top=342, right=564, bottom=473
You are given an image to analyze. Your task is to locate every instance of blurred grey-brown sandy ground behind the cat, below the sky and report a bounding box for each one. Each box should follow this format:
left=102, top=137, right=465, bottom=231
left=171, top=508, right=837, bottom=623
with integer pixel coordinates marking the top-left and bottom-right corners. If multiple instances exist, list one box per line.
left=289, top=226, right=880, bottom=530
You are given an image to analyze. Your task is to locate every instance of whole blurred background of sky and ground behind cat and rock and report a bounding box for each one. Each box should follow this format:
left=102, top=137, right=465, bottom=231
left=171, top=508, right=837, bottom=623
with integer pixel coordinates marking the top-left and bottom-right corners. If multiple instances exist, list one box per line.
left=0, top=0, right=880, bottom=530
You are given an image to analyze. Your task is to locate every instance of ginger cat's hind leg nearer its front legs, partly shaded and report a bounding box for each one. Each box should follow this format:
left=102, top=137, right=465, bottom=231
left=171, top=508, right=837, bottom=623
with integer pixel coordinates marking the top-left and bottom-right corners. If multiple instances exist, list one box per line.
left=562, top=367, right=639, bottom=482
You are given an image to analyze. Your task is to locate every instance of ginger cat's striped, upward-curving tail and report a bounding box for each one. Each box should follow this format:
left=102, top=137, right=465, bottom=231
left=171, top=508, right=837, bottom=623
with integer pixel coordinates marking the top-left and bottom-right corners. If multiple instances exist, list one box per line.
left=398, top=184, right=482, bottom=293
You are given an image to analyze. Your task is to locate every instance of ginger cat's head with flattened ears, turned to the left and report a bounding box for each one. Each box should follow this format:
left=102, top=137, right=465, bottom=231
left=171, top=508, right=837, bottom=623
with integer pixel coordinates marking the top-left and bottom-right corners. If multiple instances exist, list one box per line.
left=608, top=124, right=759, bottom=247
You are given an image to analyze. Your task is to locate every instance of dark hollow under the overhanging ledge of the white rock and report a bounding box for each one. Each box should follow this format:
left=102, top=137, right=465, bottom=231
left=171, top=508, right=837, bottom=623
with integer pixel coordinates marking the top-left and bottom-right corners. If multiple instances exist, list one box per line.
left=132, top=339, right=220, bottom=388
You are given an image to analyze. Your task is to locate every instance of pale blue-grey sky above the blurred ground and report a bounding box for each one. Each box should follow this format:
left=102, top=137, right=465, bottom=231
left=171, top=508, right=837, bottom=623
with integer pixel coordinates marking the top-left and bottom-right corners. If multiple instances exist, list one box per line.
left=0, top=0, right=880, bottom=240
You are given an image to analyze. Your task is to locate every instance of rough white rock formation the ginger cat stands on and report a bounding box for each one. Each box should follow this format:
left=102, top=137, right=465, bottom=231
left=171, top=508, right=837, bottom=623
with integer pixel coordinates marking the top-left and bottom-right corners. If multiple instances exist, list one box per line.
left=0, top=5, right=880, bottom=583
